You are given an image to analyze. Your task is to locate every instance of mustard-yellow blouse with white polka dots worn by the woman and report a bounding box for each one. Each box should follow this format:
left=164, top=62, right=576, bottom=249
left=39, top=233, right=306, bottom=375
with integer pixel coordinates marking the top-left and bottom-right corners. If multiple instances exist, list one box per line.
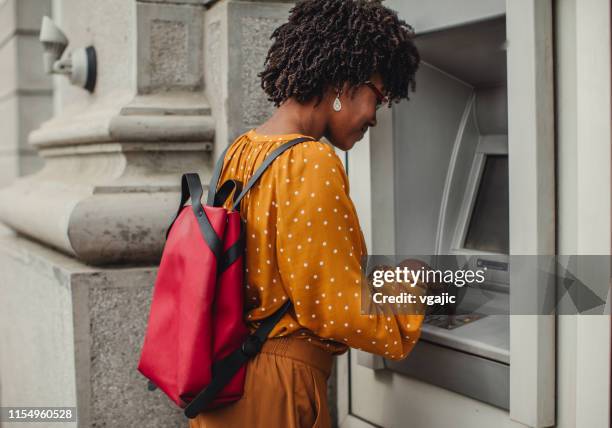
left=219, top=130, right=423, bottom=359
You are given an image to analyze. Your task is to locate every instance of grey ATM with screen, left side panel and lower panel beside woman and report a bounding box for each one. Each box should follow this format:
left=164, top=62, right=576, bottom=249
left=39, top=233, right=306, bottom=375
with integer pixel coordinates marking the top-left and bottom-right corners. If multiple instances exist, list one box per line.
left=339, top=0, right=554, bottom=428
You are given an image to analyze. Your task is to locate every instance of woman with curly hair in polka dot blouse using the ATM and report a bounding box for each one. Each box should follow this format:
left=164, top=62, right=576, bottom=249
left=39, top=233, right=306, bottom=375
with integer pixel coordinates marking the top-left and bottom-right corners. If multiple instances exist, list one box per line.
left=190, top=0, right=423, bottom=428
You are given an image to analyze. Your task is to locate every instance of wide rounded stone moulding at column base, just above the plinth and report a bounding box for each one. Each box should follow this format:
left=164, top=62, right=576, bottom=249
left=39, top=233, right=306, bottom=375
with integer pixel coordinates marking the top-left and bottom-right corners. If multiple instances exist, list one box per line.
left=0, top=143, right=211, bottom=266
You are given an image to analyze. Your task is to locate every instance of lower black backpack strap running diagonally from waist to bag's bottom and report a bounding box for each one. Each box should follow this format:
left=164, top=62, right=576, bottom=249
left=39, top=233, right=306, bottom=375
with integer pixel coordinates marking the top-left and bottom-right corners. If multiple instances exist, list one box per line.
left=185, top=300, right=291, bottom=419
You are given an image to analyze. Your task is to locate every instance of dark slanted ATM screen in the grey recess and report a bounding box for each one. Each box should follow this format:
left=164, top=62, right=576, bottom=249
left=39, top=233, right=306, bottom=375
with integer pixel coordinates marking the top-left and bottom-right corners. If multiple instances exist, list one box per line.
left=464, top=155, right=510, bottom=254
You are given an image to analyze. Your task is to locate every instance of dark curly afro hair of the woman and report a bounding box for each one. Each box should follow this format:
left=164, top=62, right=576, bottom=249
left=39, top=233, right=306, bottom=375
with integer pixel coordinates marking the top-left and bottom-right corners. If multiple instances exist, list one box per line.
left=258, top=0, right=420, bottom=106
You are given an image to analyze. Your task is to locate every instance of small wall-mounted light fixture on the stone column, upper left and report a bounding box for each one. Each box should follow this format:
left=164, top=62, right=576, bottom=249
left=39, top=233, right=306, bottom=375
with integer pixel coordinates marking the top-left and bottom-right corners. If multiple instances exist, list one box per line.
left=40, top=16, right=97, bottom=92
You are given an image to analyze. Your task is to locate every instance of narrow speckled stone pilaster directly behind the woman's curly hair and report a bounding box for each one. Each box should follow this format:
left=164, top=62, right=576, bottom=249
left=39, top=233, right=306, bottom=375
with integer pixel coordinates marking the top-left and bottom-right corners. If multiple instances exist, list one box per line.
left=204, top=0, right=293, bottom=159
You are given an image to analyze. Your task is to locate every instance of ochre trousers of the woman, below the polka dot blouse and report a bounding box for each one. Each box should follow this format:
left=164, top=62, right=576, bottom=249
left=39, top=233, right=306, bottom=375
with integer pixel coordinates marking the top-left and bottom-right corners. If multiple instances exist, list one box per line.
left=189, top=337, right=333, bottom=428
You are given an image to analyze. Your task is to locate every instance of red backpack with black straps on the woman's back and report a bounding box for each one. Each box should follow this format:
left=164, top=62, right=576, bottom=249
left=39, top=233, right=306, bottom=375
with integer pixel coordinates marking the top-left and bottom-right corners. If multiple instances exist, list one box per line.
left=138, top=137, right=312, bottom=418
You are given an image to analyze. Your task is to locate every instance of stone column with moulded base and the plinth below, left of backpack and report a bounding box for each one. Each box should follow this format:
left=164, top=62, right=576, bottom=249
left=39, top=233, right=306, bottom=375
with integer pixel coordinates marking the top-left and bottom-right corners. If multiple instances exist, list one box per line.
left=0, top=0, right=215, bottom=427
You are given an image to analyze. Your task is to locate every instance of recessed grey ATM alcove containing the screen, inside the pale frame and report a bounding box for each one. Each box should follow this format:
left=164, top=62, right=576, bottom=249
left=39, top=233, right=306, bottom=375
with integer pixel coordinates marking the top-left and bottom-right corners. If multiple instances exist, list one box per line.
left=368, top=16, right=510, bottom=409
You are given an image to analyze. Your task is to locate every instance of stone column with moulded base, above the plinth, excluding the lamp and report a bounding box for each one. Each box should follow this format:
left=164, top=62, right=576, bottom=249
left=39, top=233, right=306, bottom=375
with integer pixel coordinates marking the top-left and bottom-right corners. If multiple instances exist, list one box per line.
left=0, top=0, right=214, bottom=265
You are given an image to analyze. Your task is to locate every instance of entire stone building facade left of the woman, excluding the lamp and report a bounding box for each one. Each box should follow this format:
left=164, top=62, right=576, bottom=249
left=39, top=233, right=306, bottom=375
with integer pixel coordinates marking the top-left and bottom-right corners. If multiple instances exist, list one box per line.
left=0, top=0, right=334, bottom=427
